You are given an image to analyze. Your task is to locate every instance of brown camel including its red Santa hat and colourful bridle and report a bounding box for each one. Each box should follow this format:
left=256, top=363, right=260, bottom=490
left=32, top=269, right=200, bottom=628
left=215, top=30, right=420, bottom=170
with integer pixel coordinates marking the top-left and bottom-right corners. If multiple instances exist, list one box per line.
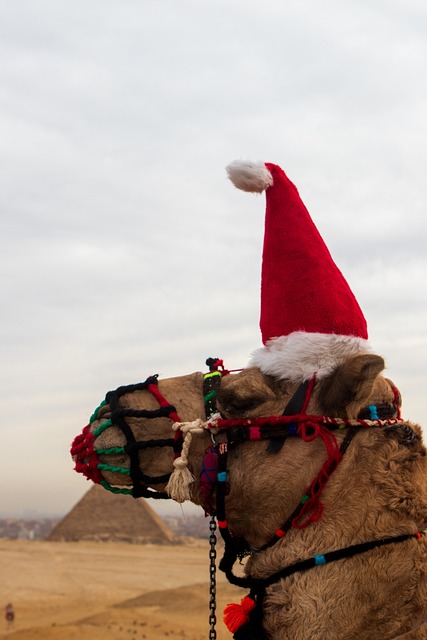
left=71, top=161, right=427, bottom=640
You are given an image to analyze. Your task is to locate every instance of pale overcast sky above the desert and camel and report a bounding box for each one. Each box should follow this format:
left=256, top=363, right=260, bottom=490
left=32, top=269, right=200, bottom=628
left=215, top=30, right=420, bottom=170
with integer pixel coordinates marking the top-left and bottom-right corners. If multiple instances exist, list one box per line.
left=0, top=0, right=427, bottom=517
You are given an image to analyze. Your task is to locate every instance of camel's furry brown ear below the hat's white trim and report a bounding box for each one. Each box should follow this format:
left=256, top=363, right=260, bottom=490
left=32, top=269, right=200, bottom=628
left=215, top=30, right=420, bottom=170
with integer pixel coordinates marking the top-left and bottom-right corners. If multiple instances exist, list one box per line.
left=318, top=354, right=385, bottom=418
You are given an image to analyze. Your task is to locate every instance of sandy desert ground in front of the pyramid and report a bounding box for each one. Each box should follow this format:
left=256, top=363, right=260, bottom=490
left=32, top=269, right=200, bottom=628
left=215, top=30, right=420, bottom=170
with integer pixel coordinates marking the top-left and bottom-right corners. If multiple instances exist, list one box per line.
left=0, top=540, right=245, bottom=640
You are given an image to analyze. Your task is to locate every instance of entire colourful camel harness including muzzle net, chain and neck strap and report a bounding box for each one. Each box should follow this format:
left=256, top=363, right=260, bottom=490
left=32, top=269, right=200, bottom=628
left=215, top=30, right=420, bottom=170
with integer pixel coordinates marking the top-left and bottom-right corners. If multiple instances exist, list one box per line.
left=71, top=358, right=424, bottom=640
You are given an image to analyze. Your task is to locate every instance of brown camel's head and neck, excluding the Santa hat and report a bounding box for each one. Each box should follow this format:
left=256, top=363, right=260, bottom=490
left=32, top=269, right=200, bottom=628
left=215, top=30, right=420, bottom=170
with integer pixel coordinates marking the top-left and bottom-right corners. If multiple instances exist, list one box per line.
left=73, top=354, right=427, bottom=640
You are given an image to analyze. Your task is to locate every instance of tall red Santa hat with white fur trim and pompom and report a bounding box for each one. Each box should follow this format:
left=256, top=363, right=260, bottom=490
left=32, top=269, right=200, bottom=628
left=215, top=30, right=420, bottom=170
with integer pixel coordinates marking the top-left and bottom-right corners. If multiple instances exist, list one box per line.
left=227, top=161, right=370, bottom=382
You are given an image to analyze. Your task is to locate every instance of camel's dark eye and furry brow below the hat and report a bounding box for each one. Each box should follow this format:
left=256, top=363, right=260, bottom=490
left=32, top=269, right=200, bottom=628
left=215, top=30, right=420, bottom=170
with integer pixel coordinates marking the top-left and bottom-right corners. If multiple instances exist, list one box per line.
left=217, top=368, right=276, bottom=418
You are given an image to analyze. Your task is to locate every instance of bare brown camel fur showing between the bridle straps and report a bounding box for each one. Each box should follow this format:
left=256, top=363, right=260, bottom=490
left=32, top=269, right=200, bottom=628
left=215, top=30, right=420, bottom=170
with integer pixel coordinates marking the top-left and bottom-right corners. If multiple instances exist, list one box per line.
left=78, top=354, right=427, bottom=640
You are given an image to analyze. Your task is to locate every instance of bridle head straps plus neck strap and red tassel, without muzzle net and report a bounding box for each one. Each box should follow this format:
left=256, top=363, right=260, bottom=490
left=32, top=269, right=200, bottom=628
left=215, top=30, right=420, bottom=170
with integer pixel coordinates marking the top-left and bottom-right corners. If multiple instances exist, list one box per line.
left=194, top=361, right=425, bottom=640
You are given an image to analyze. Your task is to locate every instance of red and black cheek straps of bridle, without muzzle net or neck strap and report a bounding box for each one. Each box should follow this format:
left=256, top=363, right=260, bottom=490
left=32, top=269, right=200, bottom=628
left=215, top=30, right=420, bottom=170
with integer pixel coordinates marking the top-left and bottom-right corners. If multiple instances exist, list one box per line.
left=201, top=362, right=408, bottom=564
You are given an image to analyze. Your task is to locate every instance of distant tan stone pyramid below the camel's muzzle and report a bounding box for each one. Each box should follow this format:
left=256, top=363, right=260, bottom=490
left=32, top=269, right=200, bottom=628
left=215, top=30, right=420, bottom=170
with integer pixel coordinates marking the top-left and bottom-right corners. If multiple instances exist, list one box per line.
left=46, top=485, right=179, bottom=544
